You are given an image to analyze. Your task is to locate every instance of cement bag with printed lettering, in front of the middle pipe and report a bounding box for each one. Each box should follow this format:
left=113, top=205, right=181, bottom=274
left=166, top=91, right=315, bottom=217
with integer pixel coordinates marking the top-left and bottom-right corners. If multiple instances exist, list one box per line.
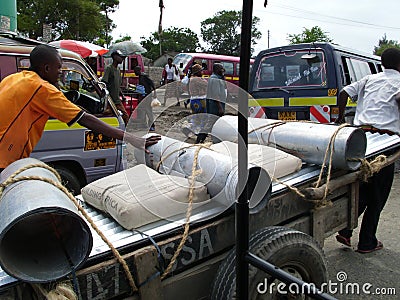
left=81, top=164, right=210, bottom=230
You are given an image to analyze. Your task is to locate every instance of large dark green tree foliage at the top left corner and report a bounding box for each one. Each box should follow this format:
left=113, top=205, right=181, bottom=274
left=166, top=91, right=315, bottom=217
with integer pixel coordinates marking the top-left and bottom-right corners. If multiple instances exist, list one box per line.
left=17, top=0, right=119, bottom=45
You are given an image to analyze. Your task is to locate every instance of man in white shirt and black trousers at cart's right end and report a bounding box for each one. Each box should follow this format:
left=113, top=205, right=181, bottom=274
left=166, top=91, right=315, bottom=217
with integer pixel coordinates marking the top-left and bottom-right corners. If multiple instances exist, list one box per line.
left=336, top=48, right=400, bottom=253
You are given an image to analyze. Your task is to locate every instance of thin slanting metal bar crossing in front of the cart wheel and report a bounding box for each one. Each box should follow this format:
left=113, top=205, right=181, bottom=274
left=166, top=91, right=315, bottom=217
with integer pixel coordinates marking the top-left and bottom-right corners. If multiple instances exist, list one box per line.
left=245, top=253, right=336, bottom=300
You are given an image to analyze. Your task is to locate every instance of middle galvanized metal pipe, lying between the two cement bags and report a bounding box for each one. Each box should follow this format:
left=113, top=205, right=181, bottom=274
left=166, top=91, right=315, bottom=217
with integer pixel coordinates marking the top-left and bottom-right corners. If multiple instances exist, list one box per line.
left=134, top=136, right=271, bottom=208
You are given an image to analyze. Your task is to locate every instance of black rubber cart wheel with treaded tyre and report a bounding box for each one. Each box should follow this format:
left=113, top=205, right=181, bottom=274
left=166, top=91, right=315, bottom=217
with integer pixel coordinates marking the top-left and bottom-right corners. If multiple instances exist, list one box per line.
left=211, top=226, right=328, bottom=300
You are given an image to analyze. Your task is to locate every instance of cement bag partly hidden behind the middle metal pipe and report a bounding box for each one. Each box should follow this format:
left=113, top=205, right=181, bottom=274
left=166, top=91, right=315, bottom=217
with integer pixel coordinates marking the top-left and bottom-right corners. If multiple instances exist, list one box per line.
left=211, top=141, right=302, bottom=178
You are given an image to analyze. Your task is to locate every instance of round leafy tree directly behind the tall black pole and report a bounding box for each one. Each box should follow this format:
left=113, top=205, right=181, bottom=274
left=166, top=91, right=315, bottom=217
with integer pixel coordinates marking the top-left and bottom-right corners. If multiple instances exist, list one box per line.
left=201, top=10, right=261, bottom=56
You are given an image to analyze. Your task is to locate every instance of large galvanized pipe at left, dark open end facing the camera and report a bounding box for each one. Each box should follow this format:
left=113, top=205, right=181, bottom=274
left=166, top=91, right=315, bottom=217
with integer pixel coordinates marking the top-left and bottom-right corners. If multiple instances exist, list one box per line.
left=0, top=158, right=93, bottom=283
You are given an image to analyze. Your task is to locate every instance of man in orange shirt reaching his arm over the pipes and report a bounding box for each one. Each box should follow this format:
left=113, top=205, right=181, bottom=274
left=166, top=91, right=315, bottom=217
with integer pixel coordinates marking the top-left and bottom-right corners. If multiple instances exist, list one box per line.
left=0, top=45, right=160, bottom=171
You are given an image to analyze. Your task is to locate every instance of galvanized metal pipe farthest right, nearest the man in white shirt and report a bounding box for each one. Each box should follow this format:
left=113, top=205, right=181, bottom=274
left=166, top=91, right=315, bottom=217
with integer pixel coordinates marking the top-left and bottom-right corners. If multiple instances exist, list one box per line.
left=211, top=116, right=367, bottom=170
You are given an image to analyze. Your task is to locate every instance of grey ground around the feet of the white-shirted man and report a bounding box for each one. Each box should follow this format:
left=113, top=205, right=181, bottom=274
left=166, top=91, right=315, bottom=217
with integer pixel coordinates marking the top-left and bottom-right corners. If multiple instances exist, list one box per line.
left=324, top=172, right=400, bottom=299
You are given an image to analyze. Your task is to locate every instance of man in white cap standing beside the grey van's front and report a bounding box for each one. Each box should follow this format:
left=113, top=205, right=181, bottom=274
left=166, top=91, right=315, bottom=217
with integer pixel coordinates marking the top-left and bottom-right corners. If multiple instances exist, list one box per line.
left=101, top=50, right=129, bottom=125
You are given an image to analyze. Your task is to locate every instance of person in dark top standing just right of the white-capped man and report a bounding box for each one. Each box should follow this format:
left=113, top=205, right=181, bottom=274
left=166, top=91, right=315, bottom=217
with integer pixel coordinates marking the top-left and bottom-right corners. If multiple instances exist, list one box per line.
left=133, top=66, right=157, bottom=131
